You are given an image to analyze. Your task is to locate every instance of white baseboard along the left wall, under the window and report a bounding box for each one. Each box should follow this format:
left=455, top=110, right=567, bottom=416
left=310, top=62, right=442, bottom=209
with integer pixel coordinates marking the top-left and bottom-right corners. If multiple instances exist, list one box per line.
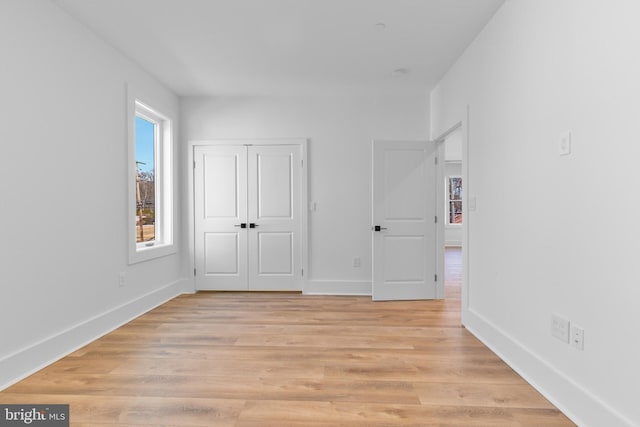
left=0, top=280, right=186, bottom=390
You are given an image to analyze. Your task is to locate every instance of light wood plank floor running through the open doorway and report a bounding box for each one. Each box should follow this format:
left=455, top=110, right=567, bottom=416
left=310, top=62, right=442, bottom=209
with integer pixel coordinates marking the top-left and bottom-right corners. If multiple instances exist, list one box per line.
left=0, top=250, right=574, bottom=427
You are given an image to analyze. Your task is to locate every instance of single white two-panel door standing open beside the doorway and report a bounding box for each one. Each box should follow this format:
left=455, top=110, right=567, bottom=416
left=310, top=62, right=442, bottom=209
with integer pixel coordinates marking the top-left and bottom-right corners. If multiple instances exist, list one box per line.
left=372, top=141, right=437, bottom=300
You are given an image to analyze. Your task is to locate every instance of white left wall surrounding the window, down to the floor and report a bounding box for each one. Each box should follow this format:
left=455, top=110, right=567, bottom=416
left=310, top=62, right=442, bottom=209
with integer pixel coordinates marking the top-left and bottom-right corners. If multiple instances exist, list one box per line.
left=0, top=0, right=184, bottom=389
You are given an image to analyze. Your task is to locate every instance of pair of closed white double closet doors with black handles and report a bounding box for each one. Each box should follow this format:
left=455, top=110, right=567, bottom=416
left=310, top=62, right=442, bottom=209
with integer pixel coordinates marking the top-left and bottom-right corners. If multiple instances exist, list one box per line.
left=194, top=144, right=302, bottom=291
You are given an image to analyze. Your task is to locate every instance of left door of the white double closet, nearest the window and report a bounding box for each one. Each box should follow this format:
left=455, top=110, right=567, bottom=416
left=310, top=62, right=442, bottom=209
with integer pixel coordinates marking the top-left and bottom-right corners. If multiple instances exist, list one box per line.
left=194, top=145, right=249, bottom=290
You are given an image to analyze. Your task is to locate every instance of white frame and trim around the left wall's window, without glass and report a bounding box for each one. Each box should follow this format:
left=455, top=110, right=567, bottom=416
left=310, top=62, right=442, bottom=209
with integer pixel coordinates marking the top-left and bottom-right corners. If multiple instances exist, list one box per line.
left=127, top=87, right=176, bottom=264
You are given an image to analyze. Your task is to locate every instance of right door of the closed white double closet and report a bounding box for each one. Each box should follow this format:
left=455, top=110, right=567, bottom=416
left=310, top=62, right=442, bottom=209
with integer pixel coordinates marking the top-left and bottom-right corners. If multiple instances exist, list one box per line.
left=248, top=145, right=302, bottom=291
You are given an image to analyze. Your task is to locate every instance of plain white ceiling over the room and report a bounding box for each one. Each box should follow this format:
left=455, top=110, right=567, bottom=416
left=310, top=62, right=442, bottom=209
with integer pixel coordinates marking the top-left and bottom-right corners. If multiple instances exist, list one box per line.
left=53, top=0, right=504, bottom=96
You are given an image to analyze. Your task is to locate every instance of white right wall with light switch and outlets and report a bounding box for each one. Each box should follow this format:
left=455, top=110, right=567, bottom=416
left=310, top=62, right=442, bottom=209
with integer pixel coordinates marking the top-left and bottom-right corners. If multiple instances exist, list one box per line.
left=431, top=0, right=640, bottom=426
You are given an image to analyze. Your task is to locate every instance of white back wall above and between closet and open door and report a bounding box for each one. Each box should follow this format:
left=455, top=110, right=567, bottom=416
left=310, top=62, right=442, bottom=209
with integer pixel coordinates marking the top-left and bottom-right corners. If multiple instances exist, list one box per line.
left=181, top=96, right=429, bottom=293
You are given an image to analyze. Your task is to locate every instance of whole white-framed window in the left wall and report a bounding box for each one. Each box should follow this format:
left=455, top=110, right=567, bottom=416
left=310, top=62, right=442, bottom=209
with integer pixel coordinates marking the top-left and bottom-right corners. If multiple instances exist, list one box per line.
left=128, top=93, right=175, bottom=263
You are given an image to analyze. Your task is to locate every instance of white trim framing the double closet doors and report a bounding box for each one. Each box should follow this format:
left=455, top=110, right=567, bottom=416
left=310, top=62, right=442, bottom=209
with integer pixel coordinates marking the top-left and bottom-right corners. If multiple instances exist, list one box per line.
left=182, top=138, right=309, bottom=294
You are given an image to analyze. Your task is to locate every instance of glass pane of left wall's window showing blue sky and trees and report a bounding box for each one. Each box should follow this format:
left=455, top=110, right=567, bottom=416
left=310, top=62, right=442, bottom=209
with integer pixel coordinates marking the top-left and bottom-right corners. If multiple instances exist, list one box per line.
left=135, top=116, right=156, bottom=243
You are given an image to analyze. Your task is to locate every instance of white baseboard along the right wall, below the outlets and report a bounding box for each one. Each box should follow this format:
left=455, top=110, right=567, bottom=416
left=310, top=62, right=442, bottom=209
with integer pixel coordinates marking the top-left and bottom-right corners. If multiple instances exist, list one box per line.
left=463, top=310, right=635, bottom=427
